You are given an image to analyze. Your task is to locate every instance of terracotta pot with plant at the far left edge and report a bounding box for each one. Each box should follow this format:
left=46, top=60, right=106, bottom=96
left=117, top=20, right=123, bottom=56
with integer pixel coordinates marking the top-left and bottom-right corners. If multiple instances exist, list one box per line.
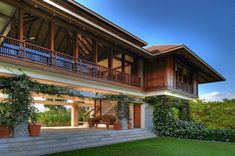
left=0, top=101, right=12, bottom=138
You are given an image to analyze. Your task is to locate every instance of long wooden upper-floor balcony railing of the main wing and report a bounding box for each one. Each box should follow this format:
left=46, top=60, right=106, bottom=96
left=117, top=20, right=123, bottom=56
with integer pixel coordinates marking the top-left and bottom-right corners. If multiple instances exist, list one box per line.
left=0, top=35, right=141, bottom=87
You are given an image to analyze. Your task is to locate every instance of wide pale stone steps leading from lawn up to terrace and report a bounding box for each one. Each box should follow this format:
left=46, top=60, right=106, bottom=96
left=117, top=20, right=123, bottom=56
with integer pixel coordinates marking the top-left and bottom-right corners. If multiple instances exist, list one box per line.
left=0, top=129, right=156, bottom=156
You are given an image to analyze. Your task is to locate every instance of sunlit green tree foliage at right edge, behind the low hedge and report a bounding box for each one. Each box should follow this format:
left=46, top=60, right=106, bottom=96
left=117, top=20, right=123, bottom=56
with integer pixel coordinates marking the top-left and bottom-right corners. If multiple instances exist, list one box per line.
left=190, top=99, right=235, bottom=129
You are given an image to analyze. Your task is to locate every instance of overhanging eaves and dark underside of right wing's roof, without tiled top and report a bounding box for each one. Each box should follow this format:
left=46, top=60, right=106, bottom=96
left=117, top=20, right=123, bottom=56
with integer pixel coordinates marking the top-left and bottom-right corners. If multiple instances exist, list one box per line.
left=152, top=45, right=226, bottom=84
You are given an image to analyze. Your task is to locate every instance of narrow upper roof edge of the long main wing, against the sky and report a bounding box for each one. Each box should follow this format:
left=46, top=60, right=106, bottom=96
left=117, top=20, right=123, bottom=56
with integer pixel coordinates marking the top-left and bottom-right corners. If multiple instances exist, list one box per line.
left=67, top=0, right=148, bottom=46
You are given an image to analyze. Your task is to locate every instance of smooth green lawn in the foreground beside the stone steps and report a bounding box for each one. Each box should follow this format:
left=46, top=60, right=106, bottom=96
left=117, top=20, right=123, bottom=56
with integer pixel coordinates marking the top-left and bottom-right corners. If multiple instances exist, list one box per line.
left=48, top=138, right=235, bottom=156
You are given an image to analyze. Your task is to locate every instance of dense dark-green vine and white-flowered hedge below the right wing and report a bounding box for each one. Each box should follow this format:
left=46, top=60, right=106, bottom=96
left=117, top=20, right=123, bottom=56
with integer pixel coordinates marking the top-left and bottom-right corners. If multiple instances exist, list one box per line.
left=145, top=96, right=235, bottom=142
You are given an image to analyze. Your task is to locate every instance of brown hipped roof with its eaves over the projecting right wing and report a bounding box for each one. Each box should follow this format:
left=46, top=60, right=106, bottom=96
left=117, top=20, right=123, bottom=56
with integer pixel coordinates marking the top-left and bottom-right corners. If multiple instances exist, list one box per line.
left=146, top=45, right=225, bottom=83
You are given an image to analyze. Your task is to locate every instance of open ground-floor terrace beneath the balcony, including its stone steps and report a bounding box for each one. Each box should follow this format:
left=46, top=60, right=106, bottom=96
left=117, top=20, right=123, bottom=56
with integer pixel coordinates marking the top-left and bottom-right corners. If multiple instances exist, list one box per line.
left=0, top=74, right=155, bottom=156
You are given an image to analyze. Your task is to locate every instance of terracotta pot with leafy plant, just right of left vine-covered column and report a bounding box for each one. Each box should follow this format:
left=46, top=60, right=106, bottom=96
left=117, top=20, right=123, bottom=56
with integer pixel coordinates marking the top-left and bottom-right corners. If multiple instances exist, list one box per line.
left=28, top=104, right=41, bottom=137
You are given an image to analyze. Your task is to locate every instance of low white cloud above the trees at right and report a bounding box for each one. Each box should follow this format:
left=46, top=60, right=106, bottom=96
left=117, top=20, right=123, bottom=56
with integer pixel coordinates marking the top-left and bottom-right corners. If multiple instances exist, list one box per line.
left=199, top=92, right=235, bottom=101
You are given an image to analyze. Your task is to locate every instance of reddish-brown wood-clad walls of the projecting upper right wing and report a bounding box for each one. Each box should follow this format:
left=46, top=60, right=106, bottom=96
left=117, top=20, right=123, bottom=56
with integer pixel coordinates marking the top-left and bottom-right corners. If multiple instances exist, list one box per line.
left=144, top=55, right=198, bottom=96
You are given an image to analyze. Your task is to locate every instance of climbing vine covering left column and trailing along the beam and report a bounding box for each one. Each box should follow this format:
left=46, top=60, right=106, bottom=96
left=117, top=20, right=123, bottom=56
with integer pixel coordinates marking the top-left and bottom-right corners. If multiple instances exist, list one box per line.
left=0, top=73, right=83, bottom=132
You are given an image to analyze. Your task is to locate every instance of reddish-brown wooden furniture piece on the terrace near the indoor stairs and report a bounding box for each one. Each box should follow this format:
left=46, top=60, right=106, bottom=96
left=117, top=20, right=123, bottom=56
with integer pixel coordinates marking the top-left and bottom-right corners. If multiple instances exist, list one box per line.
left=88, top=114, right=116, bottom=129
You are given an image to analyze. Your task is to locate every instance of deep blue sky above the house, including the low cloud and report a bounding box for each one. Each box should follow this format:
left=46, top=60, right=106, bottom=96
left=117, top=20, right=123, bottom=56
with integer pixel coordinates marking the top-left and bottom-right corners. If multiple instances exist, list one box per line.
left=77, top=0, right=235, bottom=99
